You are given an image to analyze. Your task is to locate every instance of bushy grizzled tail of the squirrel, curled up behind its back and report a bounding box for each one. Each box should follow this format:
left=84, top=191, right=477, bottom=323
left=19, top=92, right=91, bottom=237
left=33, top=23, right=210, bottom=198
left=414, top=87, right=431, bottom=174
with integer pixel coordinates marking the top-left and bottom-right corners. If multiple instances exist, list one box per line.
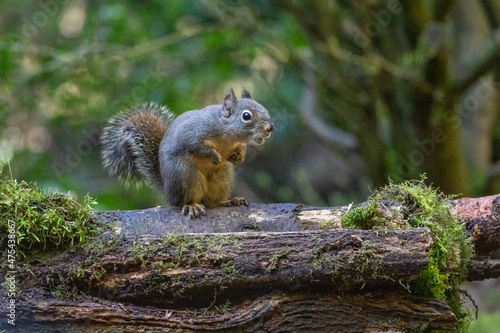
left=101, top=103, right=173, bottom=189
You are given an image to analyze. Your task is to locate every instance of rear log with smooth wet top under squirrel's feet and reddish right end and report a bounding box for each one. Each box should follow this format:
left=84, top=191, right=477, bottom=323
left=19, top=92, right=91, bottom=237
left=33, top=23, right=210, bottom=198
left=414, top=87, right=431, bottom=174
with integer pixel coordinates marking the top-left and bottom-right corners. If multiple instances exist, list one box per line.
left=96, top=195, right=500, bottom=256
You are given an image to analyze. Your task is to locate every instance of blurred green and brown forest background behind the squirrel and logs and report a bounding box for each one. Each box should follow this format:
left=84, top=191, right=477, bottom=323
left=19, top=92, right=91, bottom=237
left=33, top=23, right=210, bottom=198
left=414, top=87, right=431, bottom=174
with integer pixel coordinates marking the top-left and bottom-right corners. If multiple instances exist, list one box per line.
left=0, top=0, right=500, bottom=332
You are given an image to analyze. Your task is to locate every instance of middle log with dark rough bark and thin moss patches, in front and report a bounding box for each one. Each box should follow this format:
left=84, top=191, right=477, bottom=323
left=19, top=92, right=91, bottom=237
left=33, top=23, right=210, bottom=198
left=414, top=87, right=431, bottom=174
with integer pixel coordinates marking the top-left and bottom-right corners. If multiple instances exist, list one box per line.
left=24, top=228, right=432, bottom=307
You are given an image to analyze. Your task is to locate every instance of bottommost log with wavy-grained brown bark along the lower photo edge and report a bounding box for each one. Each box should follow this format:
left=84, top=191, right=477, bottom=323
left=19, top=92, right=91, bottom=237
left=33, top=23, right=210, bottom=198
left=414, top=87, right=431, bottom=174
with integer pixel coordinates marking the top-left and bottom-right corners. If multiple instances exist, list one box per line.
left=12, top=293, right=455, bottom=333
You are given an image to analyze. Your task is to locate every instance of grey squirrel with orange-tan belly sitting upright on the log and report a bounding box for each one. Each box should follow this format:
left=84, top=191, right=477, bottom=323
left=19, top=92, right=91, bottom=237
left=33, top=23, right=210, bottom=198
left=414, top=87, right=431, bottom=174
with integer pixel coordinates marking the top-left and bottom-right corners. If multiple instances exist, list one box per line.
left=101, top=89, right=274, bottom=219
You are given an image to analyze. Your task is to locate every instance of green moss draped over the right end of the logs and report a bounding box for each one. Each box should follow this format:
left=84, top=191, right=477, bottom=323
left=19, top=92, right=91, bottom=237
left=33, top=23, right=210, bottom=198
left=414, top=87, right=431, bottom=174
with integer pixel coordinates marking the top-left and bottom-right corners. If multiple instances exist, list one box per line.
left=341, top=176, right=473, bottom=331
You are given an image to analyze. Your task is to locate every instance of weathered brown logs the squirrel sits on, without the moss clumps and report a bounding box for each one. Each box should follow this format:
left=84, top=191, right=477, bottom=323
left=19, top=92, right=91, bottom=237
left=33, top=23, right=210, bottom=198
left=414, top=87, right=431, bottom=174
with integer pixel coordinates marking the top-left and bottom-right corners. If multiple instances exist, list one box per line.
left=0, top=196, right=500, bottom=332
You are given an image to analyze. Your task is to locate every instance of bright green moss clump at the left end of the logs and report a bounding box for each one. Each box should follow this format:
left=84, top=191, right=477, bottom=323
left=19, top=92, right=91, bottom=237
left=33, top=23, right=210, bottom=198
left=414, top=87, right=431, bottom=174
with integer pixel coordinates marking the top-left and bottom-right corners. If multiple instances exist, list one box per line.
left=0, top=165, right=100, bottom=255
